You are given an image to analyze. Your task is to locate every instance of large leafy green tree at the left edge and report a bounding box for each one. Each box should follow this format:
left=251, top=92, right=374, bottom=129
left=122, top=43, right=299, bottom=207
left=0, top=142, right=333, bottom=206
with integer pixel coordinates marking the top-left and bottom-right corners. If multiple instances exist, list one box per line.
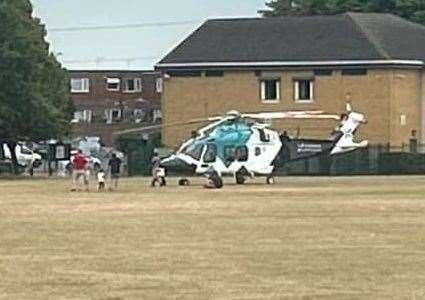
left=0, top=0, right=73, bottom=173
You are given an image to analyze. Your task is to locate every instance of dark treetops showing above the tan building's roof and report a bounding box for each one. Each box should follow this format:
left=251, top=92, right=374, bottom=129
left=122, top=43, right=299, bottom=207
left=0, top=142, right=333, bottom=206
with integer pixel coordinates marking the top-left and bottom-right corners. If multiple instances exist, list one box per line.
left=259, top=0, right=425, bottom=24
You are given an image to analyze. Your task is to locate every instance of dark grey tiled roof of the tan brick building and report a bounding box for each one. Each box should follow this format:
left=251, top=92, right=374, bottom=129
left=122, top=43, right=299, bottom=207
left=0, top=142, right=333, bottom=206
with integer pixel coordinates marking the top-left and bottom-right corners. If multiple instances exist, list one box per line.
left=157, top=13, right=425, bottom=68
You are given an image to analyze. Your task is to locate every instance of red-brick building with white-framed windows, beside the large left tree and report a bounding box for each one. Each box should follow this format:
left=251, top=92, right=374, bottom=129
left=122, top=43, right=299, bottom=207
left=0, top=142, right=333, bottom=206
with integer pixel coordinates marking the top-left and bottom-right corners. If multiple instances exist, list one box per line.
left=69, top=71, right=162, bottom=145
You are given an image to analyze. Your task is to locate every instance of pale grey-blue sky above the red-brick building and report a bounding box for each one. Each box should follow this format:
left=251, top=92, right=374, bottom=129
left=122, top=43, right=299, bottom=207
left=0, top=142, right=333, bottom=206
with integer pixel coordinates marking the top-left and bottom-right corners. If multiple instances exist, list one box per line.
left=31, top=0, right=265, bottom=70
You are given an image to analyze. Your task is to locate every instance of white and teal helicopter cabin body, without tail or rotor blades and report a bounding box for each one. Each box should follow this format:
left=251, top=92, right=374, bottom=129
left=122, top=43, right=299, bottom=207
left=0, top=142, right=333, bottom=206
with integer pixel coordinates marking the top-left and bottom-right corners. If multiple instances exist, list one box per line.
left=162, top=120, right=282, bottom=176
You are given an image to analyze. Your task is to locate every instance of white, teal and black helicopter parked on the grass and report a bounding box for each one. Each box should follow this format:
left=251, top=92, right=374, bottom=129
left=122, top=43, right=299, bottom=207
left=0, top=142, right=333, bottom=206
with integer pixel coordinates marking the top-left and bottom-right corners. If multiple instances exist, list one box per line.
left=119, top=104, right=368, bottom=185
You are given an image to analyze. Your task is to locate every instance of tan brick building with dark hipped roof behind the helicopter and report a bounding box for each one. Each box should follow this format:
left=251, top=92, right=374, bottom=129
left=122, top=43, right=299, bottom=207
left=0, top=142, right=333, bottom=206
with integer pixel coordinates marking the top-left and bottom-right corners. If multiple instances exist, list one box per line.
left=156, top=13, right=425, bottom=146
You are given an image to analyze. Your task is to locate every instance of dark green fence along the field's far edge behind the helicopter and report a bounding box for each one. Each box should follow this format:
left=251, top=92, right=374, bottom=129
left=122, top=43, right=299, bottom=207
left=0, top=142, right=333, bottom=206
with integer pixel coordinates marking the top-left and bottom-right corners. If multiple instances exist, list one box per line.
left=0, top=139, right=425, bottom=176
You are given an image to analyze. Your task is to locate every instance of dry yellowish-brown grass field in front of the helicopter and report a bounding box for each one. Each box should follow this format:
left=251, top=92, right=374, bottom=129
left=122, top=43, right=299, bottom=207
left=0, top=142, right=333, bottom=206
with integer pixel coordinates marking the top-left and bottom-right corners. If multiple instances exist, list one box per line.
left=0, top=177, right=425, bottom=300
